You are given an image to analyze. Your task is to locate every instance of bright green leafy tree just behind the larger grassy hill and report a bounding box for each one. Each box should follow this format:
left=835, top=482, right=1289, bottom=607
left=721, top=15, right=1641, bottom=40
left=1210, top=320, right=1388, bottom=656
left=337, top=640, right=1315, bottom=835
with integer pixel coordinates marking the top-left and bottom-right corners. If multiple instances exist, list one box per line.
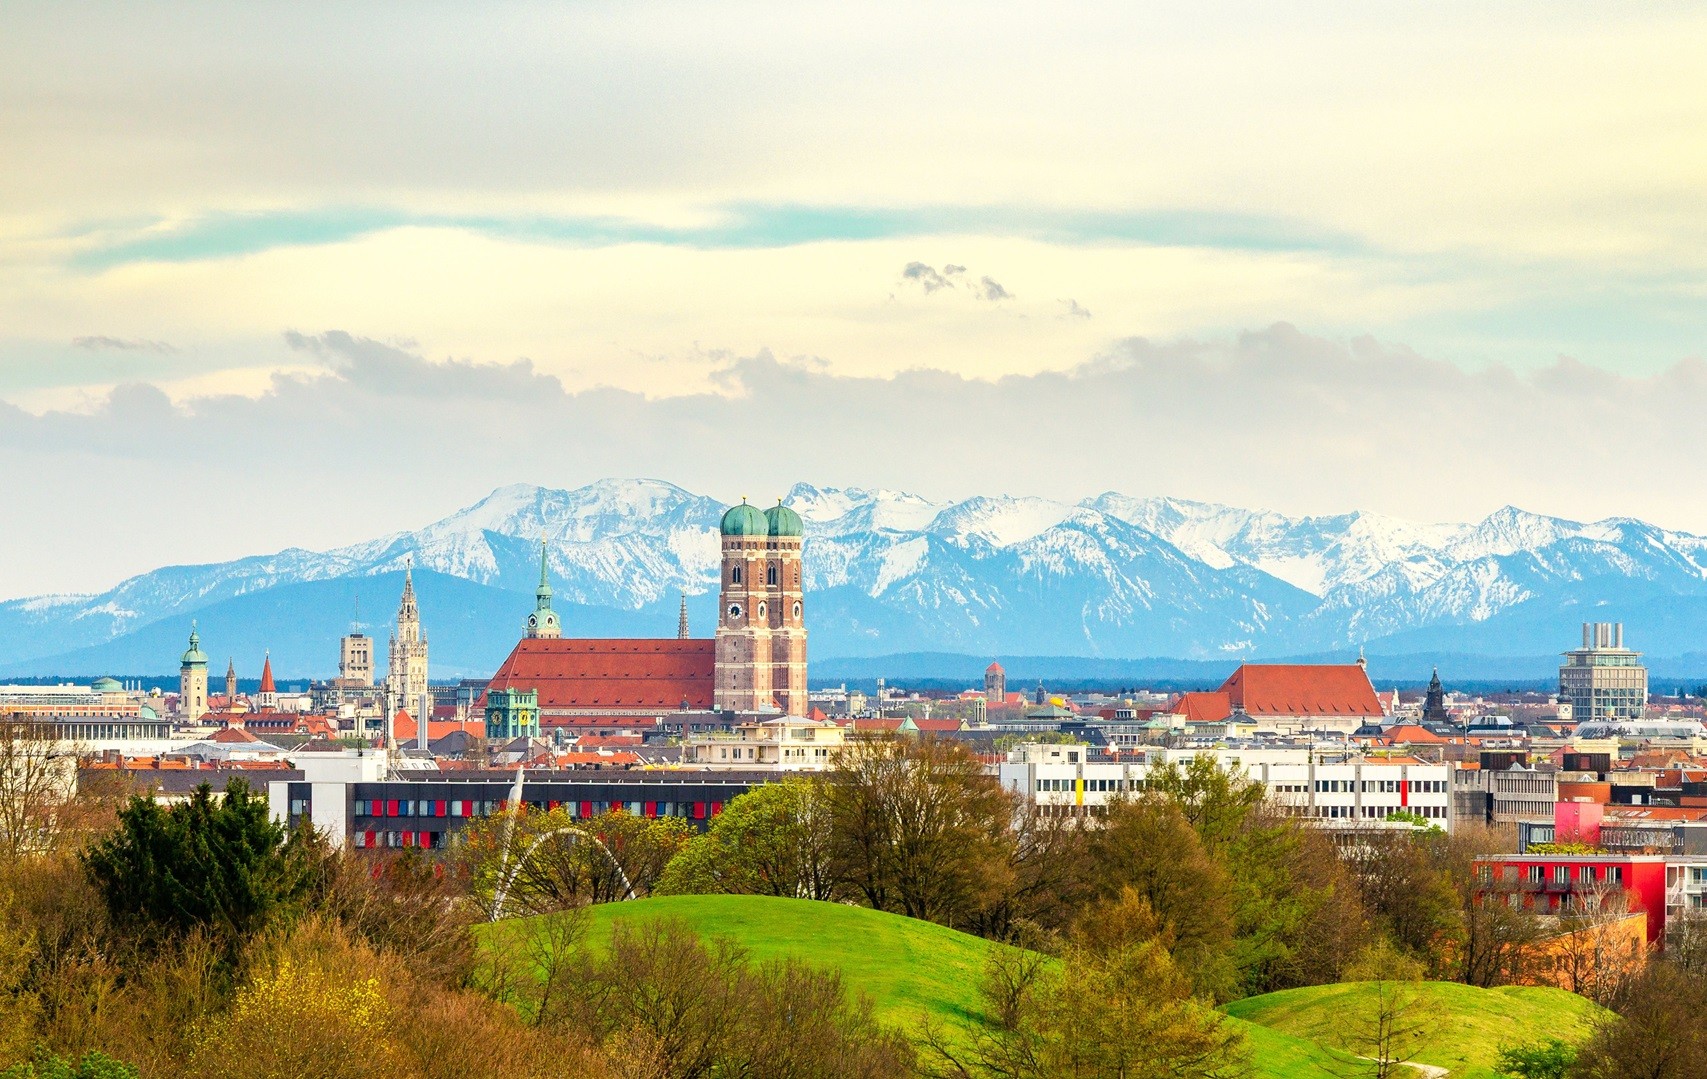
left=657, top=777, right=835, bottom=900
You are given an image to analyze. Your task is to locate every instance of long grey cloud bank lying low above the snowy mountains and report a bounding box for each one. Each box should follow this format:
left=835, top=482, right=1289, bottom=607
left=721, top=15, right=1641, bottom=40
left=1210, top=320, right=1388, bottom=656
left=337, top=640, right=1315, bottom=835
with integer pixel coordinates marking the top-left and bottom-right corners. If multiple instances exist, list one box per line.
left=10, top=324, right=1707, bottom=596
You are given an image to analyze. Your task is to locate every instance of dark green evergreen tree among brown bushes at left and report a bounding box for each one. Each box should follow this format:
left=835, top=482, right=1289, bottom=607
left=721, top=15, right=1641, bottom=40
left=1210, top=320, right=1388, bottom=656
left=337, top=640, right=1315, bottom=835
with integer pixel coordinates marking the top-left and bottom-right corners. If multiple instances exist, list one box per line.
left=82, top=779, right=324, bottom=948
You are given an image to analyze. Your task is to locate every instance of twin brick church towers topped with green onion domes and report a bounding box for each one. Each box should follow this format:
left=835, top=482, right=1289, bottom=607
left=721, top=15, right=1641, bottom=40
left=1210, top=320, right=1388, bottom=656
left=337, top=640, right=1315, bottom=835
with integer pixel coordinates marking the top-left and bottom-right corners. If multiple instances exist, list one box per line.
left=714, top=500, right=807, bottom=715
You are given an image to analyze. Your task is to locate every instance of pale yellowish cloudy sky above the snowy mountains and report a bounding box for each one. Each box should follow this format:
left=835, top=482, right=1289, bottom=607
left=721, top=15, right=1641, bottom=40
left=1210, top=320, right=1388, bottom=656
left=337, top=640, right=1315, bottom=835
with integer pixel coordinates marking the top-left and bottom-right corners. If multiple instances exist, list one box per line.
left=0, top=0, right=1707, bottom=598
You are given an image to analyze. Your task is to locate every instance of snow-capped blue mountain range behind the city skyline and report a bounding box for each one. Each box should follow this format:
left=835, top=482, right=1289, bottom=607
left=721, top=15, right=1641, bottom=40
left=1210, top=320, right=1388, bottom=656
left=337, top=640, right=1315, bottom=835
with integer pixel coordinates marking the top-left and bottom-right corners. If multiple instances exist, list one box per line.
left=0, top=480, right=1707, bottom=676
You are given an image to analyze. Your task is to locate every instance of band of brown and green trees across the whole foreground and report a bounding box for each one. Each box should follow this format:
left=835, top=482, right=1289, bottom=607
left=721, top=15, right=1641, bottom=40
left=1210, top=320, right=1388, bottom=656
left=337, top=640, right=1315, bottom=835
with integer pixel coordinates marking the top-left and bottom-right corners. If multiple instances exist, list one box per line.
left=0, top=717, right=1707, bottom=1079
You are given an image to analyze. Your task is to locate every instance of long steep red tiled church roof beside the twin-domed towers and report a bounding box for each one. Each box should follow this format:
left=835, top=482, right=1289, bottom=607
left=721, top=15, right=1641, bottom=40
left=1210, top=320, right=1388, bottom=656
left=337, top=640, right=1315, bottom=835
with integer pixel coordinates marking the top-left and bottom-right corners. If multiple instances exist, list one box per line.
left=490, top=637, right=717, bottom=712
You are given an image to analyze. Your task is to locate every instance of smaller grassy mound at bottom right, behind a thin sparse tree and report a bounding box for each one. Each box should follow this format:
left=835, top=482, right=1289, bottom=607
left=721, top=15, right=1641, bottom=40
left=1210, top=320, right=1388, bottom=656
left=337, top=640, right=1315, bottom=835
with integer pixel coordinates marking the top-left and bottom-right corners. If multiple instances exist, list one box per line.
left=1224, top=982, right=1605, bottom=1079
